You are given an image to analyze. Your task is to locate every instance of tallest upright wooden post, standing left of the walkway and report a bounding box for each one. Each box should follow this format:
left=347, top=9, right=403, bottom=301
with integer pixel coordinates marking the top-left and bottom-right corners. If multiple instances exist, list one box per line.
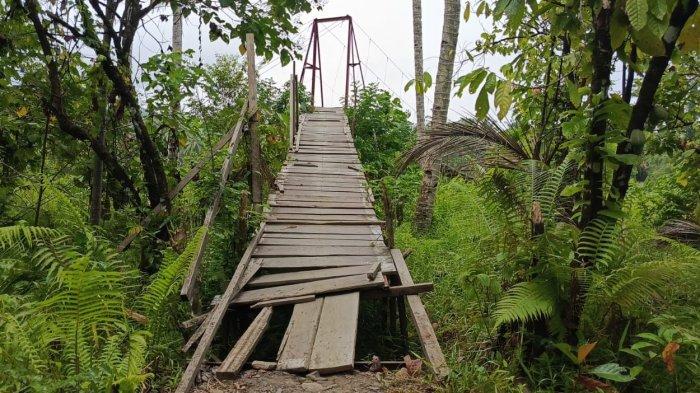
left=245, top=33, right=262, bottom=213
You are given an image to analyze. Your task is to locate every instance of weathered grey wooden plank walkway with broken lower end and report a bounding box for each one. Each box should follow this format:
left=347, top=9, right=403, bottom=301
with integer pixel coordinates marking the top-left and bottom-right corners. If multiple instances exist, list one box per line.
left=177, top=108, right=447, bottom=392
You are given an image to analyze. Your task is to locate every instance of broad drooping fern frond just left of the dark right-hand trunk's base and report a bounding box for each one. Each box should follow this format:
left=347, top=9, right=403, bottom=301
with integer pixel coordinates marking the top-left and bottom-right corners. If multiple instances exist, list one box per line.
left=494, top=281, right=557, bottom=325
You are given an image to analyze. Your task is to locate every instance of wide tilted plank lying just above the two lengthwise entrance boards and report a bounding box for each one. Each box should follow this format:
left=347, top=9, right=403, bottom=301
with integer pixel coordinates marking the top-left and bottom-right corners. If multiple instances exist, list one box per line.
left=232, top=274, right=384, bottom=305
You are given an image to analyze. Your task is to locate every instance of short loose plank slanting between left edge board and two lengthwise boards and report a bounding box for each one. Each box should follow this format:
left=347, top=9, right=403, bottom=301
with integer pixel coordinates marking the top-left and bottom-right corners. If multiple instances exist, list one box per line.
left=216, top=307, right=272, bottom=378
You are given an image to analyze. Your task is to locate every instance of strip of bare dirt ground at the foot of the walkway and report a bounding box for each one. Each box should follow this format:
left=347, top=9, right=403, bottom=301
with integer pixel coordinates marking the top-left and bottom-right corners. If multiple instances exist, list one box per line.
left=194, top=370, right=435, bottom=393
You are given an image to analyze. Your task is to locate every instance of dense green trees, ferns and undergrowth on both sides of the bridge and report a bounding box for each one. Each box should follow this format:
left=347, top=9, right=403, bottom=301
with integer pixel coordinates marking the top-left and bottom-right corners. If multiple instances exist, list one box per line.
left=0, top=0, right=700, bottom=392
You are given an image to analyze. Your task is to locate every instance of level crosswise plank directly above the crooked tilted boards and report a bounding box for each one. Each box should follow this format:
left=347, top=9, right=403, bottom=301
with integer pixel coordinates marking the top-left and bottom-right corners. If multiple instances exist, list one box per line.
left=259, top=255, right=393, bottom=270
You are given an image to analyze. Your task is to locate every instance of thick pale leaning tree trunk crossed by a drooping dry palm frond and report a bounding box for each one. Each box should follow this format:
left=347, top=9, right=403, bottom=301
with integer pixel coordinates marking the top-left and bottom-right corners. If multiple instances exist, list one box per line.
left=414, top=0, right=460, bottom=231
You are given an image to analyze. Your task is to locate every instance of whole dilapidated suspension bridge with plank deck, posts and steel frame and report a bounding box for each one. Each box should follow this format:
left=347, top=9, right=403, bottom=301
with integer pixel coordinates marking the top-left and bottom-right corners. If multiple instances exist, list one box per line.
left=161, top=16, right=448, bottom=393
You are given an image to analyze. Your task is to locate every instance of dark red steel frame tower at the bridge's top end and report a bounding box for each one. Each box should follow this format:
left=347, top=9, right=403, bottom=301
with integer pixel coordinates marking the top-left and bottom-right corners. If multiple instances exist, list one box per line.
left=299, top=15, right=365, bottom=106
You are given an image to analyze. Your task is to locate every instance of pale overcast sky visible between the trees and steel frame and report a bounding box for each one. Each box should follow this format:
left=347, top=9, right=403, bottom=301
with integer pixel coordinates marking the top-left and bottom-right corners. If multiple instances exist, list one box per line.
left=134, top=0, right=505, bottom=120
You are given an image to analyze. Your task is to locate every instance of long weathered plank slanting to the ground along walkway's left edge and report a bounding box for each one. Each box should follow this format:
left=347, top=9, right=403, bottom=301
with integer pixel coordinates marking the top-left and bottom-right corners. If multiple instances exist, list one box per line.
left=175, top=223, right=265, bottom=393
